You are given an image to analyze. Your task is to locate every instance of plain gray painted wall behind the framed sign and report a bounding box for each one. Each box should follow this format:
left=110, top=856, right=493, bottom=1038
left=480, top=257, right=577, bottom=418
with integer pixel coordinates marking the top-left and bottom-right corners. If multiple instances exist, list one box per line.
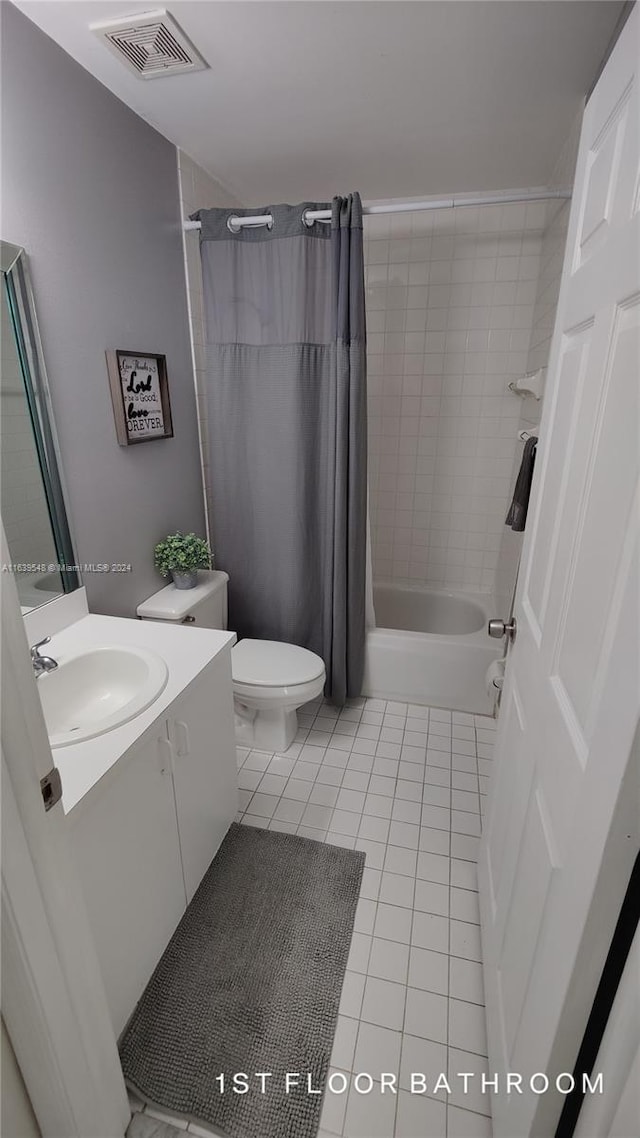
left=1, top=3, right=205, bottom=616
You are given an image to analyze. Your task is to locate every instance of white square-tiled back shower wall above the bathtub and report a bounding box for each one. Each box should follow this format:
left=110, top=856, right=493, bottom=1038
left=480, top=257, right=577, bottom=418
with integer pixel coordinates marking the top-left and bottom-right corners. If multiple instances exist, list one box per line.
left=366, top=203, right=545, bottom=592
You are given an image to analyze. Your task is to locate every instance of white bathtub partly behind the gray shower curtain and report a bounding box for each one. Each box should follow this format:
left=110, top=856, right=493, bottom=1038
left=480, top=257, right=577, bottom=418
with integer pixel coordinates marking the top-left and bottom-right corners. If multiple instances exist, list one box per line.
left=362, top=584, right=502, bottom=715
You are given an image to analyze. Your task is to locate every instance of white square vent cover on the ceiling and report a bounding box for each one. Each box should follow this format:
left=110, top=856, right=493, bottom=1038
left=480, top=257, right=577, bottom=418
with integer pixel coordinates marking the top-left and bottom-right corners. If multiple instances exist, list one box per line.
left=89, top=8, right=207, bottom=79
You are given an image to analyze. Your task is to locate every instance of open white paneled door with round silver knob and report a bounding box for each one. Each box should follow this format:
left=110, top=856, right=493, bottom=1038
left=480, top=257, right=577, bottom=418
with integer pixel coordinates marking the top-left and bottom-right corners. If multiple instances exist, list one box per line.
left=479, top=9, right=640, bottom=1138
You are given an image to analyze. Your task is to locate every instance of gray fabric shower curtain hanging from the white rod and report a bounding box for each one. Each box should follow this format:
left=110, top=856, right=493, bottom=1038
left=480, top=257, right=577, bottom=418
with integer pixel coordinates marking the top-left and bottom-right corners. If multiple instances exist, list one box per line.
left=194, top=193, right=367, bottom=704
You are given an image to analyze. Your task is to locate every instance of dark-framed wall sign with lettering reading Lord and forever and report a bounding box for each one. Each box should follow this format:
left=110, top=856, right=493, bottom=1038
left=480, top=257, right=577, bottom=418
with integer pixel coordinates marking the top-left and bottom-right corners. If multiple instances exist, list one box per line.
left=107, top=348, right=173, bottom=446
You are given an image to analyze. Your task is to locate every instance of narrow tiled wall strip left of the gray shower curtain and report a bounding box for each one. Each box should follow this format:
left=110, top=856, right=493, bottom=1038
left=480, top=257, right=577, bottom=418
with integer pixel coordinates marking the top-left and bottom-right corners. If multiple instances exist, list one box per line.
left=178, top=150, right=241, bottom=541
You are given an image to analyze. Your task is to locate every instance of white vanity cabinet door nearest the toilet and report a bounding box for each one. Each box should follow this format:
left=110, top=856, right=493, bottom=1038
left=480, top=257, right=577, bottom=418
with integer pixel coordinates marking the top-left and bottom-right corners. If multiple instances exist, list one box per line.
left=169, top=652, right=238, bottom=901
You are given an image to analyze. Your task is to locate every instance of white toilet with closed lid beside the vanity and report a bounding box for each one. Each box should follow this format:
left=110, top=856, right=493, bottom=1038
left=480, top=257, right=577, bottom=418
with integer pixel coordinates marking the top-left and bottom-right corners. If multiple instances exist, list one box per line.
left=137, top=569, right=326, bottom=751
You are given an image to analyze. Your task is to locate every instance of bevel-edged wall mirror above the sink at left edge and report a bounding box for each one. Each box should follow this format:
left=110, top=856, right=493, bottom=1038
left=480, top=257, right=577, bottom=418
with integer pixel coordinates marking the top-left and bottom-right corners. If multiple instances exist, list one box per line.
left=0, top=241, right=81, bottom=612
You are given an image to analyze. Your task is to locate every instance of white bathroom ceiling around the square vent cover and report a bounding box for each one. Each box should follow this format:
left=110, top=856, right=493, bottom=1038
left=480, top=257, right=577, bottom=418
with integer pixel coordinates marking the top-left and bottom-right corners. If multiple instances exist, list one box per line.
left=17, top=0, right=621, bottom=205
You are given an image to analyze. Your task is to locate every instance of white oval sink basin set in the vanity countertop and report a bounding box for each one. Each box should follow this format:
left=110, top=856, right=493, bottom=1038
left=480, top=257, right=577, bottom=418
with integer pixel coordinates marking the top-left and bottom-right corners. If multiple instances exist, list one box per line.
left=38, top=645, right=169, bottom=748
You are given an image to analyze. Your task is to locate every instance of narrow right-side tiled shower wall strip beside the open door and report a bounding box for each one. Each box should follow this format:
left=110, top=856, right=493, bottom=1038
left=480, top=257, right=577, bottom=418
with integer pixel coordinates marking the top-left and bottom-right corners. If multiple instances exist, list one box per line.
left=495, top=120, right=582, bottom=616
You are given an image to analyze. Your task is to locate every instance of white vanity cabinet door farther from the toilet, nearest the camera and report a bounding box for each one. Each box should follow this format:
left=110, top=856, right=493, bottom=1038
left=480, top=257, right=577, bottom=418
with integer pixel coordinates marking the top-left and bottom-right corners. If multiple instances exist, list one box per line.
left=71, top=719, right=186, bottom=1034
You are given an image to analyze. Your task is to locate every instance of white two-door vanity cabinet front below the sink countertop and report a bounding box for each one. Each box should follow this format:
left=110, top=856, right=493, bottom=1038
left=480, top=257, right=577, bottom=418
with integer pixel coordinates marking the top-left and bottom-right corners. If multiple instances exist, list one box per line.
left=68, top=652, right=237, bottom=1034
